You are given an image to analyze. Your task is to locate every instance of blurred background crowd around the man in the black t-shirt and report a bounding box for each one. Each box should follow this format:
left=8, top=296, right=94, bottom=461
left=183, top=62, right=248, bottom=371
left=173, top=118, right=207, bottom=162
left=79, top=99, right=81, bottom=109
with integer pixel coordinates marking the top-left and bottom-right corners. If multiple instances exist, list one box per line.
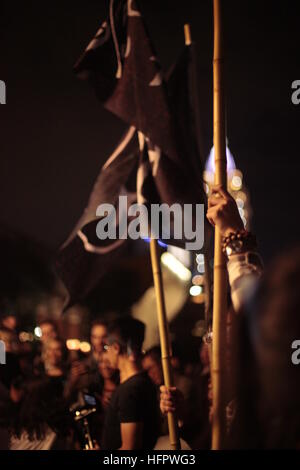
left=0, top=315, right=210, bottom=450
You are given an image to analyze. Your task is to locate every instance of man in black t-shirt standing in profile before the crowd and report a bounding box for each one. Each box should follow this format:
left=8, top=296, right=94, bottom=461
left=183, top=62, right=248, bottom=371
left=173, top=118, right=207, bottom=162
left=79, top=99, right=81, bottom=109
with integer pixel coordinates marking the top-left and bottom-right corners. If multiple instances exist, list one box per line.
left=101, top=317, right=159, bottom=450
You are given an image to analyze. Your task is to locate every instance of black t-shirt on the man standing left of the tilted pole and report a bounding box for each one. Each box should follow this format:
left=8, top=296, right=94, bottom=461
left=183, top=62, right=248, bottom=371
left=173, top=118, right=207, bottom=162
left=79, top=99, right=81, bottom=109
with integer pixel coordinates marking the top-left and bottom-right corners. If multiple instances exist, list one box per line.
left=102, top=372, right=159, bottom=450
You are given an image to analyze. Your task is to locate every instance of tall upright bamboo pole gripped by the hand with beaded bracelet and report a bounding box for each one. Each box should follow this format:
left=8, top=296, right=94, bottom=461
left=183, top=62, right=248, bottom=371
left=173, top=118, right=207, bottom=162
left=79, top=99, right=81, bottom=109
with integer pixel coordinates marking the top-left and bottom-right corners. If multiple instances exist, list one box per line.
left=211, top=0, right=227, bottom=450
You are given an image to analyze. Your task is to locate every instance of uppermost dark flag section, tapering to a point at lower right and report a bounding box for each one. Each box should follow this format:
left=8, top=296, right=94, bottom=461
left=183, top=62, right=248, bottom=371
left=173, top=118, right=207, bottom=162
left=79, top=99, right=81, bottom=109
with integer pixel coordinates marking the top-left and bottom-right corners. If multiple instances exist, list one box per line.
left=75, top=0, right=177, bottom=157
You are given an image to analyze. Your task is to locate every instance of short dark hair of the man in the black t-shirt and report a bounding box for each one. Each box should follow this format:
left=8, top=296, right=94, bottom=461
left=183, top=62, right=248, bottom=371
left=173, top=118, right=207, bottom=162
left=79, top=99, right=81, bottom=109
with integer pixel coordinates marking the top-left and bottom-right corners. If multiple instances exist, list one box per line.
left=108, top=316, right=145, bottom=353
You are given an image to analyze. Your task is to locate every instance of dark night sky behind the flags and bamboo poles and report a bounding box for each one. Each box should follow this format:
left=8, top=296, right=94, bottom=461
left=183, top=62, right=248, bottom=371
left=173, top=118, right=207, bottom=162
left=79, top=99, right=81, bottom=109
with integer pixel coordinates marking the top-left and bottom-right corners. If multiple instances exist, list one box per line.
left=0, top=0, right=300, bottom=258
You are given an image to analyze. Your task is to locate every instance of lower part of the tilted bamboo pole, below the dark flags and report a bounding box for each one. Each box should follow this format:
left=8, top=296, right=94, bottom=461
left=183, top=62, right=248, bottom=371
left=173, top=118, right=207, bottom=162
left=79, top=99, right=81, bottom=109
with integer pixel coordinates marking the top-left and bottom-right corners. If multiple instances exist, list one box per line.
left=150, top=238, right=180, bottom=450
